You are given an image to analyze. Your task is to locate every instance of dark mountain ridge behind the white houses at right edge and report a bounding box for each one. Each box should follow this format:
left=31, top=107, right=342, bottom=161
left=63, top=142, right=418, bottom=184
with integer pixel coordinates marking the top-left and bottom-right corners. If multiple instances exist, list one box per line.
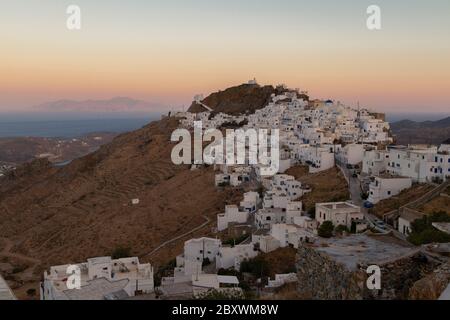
left=391, top=117, right=450, bottom=144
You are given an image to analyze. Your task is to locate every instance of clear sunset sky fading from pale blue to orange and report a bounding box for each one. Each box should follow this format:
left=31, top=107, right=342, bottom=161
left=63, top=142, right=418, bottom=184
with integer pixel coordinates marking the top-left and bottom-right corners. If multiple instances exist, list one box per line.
left=0, top=0, right=450, bottom=113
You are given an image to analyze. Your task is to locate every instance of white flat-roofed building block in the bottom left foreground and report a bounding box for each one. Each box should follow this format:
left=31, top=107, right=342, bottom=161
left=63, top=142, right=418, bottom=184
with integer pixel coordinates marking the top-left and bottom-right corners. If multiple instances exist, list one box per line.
left=40, top=257, right=154, bottom=300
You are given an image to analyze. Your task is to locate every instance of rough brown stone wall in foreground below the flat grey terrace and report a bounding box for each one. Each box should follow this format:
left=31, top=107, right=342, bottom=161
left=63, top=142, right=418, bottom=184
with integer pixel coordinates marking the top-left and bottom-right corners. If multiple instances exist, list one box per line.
left=296, top=245, right=437, bottom=300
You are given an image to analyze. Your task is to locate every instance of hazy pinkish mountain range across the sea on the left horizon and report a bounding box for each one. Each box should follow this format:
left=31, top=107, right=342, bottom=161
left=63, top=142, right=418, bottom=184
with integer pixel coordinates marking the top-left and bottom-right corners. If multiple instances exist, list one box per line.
left=35, top=97, right=165, bottom=112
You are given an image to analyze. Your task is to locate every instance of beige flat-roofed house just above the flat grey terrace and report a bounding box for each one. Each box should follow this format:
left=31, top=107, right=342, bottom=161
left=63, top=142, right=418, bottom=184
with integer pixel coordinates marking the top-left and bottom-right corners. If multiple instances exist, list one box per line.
left=316, top=202, right=364, bottom=228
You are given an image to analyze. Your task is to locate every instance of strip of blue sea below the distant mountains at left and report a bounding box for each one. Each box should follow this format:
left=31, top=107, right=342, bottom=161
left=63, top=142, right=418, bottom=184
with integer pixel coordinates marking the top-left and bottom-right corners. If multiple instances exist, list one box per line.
left=0, top=113, right=161, bottom=138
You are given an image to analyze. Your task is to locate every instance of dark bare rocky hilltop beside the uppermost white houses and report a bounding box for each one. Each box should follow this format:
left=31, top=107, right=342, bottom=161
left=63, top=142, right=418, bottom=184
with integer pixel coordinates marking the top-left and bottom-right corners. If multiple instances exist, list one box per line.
left=188, top=84, right=309, bottom=115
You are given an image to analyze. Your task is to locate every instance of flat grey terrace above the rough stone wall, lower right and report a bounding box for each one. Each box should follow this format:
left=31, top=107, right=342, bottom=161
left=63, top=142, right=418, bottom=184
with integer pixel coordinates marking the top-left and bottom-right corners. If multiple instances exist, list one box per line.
left=315, top=234, right=417, bottom=270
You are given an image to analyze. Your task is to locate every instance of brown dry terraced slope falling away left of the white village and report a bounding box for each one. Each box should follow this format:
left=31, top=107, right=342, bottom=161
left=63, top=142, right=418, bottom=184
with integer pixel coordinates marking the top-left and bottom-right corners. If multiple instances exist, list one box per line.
left=0, top=118, right=243, bottom=296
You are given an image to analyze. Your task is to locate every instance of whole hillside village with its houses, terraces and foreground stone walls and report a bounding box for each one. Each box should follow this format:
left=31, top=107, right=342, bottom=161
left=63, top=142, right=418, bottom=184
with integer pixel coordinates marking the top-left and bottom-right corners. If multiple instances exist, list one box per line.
left=4, top=80, right=450, bottom=300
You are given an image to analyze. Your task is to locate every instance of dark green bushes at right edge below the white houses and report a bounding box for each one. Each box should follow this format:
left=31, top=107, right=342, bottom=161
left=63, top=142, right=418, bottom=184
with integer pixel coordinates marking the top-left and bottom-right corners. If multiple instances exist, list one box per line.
left=408, top=211, right=450, bottom=246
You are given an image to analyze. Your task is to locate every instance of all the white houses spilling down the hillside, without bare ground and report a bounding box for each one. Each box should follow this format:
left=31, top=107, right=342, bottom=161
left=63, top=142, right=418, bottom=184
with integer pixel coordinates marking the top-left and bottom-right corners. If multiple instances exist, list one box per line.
left=30, top=82, right=450, bottom=299
